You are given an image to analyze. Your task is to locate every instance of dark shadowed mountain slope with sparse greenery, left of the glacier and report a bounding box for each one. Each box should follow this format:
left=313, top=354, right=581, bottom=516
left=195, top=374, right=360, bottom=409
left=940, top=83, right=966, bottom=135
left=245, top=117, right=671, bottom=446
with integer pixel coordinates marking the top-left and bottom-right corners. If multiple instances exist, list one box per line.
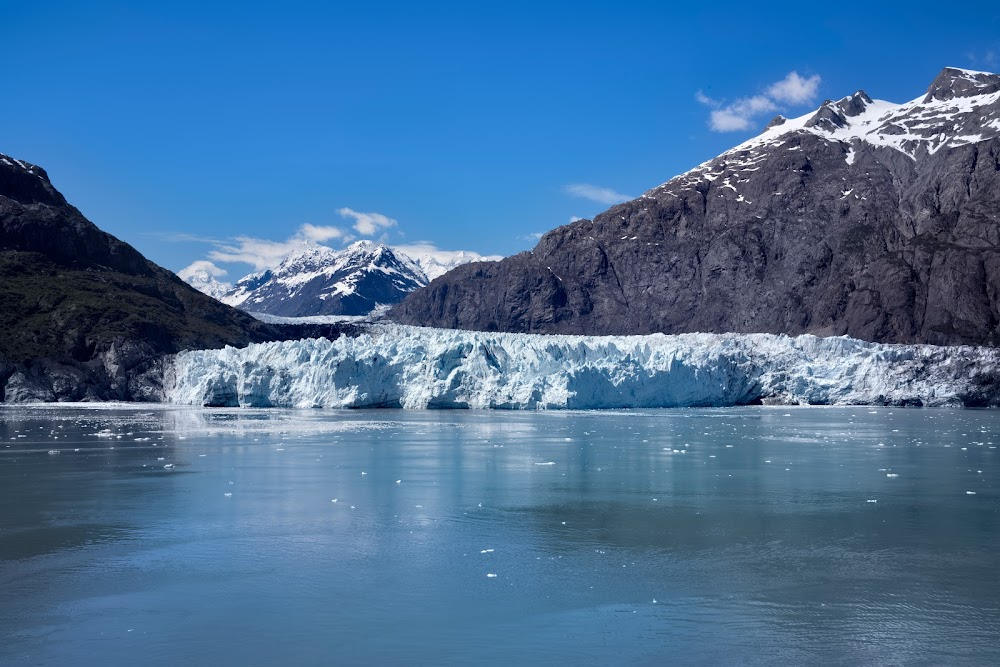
left=0, top=154, right=326, bottom=401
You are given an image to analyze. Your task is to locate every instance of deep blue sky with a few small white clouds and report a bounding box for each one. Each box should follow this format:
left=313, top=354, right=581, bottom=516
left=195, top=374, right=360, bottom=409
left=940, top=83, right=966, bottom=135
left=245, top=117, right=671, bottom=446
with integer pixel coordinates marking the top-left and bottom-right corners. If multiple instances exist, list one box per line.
left=0, top=0, right=1000, bottom=279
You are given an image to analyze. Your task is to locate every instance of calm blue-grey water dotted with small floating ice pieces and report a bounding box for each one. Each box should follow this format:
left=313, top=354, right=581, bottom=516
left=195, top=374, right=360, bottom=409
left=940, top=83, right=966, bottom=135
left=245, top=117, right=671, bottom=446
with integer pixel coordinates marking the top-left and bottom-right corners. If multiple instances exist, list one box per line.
left=0, top=406, right=1000, bottom=665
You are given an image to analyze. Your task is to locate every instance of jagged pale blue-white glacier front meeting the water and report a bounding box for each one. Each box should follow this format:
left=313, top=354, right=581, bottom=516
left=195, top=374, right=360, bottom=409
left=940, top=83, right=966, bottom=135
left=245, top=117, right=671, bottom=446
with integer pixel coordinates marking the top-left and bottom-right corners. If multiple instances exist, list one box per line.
left=164, top=324, right=1000, bottom=409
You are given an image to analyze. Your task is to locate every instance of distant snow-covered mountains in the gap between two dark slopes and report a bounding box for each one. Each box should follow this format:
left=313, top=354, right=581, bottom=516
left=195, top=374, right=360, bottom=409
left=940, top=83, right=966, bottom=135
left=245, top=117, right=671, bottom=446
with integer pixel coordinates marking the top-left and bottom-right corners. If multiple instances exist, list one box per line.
left=182, top=240, right=500, bottom=317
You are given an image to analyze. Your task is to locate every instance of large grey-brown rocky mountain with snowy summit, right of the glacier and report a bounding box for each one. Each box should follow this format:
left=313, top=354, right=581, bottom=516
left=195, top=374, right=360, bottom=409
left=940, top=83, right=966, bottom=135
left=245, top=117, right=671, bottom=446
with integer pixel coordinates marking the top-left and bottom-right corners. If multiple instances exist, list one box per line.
left=389, top=68, right=1000, bottom=345
